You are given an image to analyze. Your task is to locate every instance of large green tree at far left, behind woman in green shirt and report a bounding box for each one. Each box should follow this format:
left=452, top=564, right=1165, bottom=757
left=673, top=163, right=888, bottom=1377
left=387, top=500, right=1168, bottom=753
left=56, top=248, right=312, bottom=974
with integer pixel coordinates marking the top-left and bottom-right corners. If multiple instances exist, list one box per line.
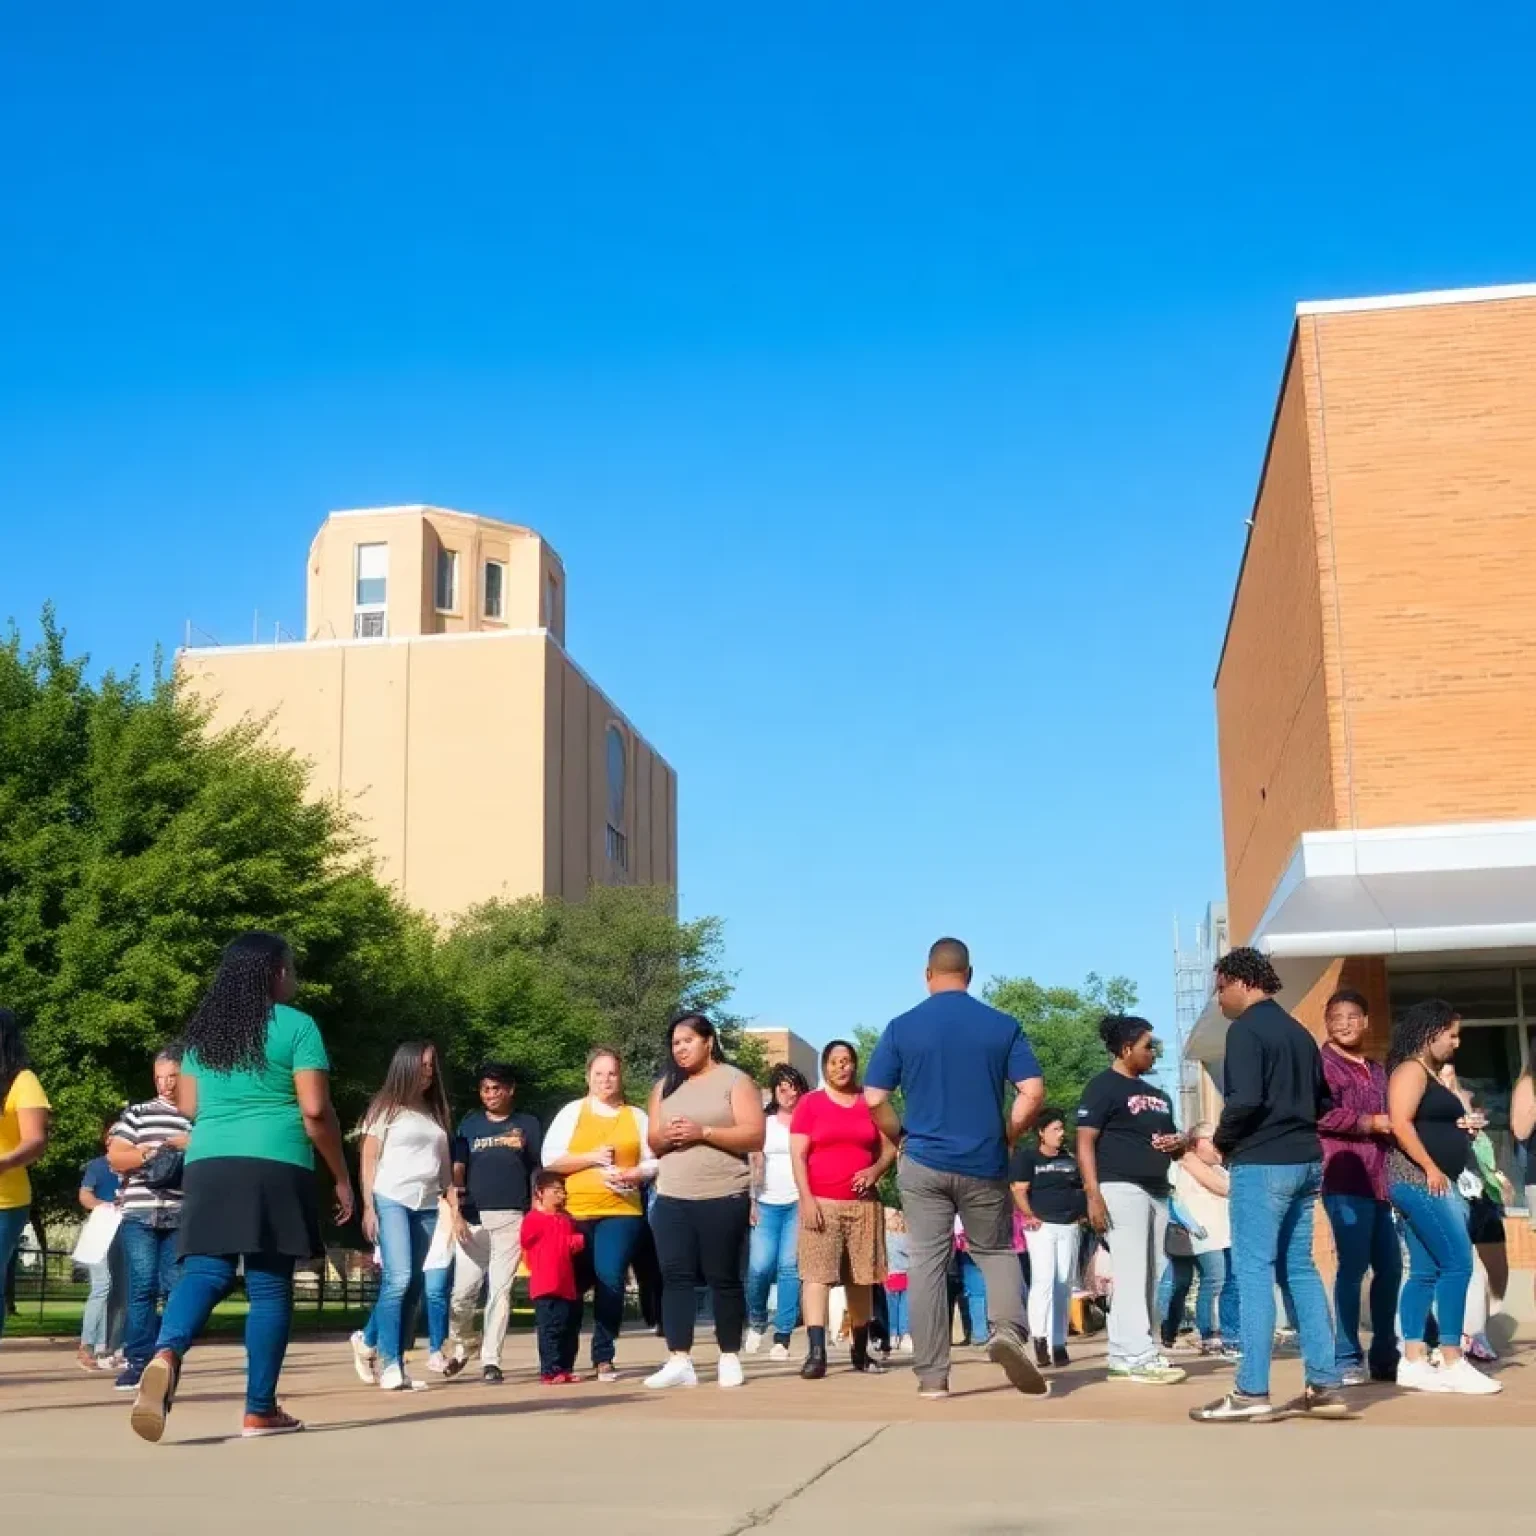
left=0, top=611, right=442, bottom=1218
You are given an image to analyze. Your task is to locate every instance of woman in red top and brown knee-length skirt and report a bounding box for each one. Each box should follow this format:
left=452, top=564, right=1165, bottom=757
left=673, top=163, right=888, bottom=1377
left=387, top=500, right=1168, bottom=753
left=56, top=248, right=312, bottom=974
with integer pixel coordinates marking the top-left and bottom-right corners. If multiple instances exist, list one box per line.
left=790, top=1040, right=895, bottom=1381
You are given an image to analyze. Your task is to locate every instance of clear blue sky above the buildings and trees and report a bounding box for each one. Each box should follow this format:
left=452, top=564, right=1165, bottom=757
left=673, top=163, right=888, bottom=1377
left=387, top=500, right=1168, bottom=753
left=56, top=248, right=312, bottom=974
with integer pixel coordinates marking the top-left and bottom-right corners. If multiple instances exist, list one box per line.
left=9, top=0, right=1536, bottom=1040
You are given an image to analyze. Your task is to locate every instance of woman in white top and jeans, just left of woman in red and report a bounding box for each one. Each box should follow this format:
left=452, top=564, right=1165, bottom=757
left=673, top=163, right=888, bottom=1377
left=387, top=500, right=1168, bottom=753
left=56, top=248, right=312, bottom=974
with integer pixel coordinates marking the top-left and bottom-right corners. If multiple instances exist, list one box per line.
left=745, top=1061, right=811, bottom=1359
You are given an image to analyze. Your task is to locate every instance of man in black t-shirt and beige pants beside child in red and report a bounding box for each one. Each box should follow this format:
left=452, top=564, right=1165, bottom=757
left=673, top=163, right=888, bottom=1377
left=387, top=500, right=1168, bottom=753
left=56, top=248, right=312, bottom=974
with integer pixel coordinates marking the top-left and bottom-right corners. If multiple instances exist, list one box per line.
left=449, top=1061, right=544, bottom=1384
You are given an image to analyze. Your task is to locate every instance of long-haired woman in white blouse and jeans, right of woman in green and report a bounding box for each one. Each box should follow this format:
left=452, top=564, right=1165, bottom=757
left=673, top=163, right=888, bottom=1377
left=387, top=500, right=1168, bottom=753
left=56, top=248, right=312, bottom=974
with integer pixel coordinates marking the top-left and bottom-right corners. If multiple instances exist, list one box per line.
left=352, top=1040, right=458, bottom=1392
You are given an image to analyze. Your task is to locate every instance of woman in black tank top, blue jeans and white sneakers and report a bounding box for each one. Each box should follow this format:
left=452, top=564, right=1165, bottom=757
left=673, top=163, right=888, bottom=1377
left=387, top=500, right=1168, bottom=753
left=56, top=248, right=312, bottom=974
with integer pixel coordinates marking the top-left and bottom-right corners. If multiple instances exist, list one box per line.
left=1387, top=998, right=1502, bottom=1396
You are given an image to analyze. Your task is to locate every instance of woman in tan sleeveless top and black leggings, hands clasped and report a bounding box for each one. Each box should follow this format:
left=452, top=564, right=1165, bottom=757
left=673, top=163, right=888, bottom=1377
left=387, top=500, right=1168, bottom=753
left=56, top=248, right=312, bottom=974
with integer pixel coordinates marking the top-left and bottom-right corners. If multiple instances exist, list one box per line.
left=645, top=1014, right=763, bottom=1389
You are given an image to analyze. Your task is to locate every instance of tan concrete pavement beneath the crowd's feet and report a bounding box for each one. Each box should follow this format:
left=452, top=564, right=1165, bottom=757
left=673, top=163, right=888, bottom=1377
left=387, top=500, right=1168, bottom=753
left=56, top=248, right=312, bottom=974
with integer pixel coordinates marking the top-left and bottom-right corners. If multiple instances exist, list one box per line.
left=0, top=1333, right=1536, bottom=1536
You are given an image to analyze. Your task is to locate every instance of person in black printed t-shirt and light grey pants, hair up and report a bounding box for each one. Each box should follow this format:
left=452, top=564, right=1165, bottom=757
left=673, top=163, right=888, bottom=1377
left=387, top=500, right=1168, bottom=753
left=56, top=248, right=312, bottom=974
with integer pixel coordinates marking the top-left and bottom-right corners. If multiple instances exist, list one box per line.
left=1077, top=1014, right=1186, bottom=1387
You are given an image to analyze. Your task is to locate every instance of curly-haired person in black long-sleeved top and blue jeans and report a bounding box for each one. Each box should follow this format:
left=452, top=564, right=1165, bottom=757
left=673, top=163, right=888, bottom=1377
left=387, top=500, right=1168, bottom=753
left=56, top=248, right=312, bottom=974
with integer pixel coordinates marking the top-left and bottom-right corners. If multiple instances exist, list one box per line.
left=1190, top=948, right=1350, bottom=1424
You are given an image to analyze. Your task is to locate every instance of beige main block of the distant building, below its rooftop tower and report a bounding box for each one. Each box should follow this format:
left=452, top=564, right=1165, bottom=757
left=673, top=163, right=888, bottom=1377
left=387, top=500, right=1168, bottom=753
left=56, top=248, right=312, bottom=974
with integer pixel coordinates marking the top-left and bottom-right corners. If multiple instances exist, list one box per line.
left=178, top=631, right=677, bottom=919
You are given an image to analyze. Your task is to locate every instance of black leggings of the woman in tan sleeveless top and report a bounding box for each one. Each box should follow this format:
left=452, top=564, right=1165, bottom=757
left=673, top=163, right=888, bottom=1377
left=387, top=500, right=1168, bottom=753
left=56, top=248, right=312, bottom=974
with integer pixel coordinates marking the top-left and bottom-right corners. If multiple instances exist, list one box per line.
left=651, top=1195, right=753, bottom=1355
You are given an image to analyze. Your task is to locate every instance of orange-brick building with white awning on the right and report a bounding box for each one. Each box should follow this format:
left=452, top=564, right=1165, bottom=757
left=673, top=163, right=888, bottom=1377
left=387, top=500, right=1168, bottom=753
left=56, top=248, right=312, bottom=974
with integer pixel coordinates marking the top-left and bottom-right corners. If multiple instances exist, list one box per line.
left=1186, top=284, right=1536, bottom=1263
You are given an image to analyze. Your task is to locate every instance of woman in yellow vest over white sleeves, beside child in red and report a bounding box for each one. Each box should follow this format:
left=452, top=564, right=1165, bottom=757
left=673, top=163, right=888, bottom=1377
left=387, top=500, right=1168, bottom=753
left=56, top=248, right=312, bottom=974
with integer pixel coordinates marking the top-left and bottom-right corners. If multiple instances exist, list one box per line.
left=544, top=1046, right=656, bottom=1381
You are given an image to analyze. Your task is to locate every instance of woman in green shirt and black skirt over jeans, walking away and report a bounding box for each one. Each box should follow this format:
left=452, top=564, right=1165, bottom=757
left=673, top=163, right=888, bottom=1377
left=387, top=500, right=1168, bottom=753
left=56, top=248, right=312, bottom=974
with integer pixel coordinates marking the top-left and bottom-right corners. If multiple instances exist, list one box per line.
left=132, top=932, right=353, bottom=1441
